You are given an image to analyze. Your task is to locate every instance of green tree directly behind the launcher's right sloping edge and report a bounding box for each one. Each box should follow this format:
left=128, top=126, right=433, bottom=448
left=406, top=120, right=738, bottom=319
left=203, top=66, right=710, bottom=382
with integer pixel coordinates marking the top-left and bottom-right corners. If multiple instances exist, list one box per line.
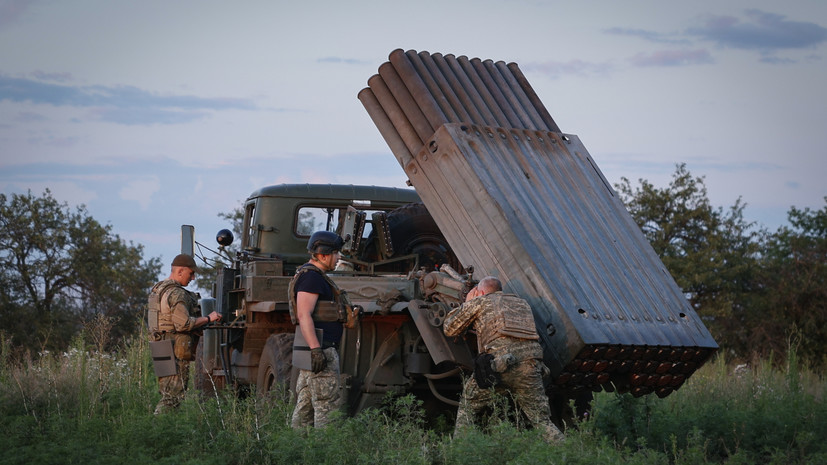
left=615, top=164, right=760, bottom=354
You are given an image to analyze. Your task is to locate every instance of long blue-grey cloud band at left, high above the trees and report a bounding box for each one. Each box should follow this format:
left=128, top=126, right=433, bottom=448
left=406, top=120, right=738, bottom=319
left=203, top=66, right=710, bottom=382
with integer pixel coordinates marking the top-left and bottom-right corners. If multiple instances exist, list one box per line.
left=0, top=72, right=257, bottom=125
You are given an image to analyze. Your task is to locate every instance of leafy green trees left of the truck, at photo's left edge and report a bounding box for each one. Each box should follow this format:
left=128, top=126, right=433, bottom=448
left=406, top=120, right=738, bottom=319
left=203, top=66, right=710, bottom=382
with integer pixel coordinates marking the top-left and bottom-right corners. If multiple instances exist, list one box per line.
left=0, top=189, right=161, bottom=350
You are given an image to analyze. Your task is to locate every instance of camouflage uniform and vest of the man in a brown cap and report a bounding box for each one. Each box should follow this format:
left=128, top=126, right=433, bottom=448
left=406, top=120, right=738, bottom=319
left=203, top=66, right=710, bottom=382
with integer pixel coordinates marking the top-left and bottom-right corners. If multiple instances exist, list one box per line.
left=150, top=279, right=199, bottom=415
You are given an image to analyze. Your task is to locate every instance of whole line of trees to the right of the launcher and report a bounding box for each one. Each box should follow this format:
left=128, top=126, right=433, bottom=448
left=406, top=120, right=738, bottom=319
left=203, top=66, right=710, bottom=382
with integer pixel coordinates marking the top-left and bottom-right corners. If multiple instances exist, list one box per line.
left=615, top=164, right=827, bottom=368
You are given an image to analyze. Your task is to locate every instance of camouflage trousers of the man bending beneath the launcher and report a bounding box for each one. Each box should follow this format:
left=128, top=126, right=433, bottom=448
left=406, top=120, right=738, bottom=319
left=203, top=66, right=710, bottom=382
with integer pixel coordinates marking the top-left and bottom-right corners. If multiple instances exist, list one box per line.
left=455, top=359, right=564, bottom=442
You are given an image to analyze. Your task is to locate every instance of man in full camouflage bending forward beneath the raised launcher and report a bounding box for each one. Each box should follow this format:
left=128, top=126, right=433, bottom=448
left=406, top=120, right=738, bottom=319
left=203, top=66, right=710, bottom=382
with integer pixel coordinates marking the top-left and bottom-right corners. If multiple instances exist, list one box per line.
left=443, top=276, right=564, bottom=442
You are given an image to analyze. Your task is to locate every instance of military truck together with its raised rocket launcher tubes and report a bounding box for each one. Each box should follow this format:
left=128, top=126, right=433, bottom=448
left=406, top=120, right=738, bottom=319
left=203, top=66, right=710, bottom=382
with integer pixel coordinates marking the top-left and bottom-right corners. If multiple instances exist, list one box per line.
left=188, top=49, right=718, bottom=422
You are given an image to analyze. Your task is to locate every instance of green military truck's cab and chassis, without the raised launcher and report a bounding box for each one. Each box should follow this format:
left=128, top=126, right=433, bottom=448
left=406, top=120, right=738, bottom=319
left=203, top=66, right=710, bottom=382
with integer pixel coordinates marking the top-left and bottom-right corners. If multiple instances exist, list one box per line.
left=193, top=184, right=473, bottom=412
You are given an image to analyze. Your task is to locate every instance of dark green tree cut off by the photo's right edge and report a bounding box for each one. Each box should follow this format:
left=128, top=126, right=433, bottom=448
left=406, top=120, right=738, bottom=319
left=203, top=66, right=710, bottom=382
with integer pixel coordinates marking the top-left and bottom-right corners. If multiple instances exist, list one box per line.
left=743, top=197, right=827, bottom=367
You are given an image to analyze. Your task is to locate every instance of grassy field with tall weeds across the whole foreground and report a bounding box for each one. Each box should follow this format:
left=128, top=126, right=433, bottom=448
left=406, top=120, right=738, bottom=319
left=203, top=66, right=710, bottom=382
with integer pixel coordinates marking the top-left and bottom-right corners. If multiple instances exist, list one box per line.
left=0, top=332, right=827, bottom=465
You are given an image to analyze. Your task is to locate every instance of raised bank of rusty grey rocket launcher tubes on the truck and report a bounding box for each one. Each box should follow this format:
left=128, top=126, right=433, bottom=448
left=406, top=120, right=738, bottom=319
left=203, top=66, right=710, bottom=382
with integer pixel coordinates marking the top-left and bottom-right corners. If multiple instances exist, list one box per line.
left=359, top=49, right=718, bottom=397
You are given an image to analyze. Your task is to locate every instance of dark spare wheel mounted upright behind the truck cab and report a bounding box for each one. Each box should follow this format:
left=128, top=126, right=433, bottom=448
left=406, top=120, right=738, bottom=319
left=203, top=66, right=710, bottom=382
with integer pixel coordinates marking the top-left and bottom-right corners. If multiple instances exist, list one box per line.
left=362, top=202, right=461, bottom=272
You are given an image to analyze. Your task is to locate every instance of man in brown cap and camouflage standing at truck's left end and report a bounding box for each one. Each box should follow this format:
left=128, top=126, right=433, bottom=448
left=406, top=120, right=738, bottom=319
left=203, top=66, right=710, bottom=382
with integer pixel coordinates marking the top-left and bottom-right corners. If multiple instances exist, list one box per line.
left=149, top=254, right=221, bottom=415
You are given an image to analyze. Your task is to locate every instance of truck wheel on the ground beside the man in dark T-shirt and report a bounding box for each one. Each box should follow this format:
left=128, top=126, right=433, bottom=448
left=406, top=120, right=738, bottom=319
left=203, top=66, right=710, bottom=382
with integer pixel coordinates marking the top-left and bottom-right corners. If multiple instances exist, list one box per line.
left=256, top=333, right=298, bottom=401
